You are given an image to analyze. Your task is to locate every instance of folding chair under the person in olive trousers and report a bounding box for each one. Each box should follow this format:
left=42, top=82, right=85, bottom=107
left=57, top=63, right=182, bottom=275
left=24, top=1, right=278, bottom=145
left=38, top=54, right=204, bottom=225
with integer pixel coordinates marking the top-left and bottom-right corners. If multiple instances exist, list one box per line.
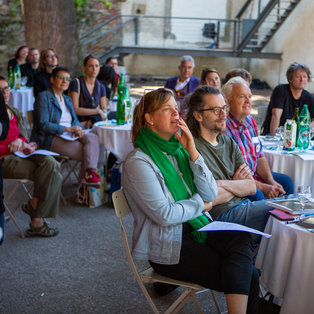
left=3, top=178, right=32, bottom=238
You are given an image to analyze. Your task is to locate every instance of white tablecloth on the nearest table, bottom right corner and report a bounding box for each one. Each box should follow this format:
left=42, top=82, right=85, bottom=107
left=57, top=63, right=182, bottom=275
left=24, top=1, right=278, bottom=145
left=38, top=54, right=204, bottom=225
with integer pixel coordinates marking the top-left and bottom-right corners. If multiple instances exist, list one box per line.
left=255, top=216, right=314, bottom=314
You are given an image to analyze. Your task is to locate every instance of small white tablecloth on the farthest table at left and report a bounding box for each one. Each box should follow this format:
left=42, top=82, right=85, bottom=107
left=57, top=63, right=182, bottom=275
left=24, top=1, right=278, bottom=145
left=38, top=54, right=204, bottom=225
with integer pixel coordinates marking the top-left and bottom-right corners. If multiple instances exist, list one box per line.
left=9, top=88, right=35, bottom=117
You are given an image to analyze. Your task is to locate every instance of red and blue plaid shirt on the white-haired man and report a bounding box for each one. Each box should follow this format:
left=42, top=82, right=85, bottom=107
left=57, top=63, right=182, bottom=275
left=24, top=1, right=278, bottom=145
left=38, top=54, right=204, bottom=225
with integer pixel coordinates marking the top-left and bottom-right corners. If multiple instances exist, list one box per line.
left=225, top=113, right=264, bottom=174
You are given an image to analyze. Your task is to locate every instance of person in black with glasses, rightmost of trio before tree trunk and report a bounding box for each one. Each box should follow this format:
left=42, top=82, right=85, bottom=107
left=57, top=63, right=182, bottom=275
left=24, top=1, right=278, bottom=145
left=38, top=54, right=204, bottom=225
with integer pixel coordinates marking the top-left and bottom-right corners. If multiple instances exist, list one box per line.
left=33, top=48, right=58, bottom=98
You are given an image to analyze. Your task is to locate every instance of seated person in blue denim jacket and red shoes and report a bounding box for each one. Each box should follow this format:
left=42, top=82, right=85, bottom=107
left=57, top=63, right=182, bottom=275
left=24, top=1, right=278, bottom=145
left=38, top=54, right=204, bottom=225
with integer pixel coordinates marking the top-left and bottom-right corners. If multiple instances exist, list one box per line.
left=32, top=67, right=100, bottom=187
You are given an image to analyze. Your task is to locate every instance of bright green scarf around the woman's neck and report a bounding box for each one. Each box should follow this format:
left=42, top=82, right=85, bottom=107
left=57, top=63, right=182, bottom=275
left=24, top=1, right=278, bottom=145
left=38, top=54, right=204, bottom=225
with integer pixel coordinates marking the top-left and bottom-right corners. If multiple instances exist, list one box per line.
left=134, top=128, right=209, bottom=243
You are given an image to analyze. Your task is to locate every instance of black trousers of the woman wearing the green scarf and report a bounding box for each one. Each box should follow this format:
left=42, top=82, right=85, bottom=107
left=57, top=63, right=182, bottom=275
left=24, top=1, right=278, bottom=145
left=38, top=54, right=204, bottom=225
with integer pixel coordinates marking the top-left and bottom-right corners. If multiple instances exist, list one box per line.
left=150, top=224, right=259, bottom=313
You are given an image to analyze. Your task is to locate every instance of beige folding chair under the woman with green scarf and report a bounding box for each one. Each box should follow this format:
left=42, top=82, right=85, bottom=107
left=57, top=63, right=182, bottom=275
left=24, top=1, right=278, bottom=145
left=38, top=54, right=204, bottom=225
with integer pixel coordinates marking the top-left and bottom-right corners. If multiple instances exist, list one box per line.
left=112, top=190, right=221, bottom=313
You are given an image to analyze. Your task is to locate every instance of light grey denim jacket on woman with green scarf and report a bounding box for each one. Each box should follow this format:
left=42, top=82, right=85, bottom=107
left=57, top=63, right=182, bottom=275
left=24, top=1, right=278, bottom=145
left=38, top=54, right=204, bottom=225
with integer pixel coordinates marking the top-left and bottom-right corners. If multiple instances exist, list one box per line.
left=122, top=148, right=217, bottom=265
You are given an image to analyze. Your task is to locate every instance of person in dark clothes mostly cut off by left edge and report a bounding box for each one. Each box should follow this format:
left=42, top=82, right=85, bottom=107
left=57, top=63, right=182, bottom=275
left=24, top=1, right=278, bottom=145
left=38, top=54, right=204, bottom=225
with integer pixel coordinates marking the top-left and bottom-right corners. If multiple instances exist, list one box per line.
left=0, top=92, right=9, bottom=245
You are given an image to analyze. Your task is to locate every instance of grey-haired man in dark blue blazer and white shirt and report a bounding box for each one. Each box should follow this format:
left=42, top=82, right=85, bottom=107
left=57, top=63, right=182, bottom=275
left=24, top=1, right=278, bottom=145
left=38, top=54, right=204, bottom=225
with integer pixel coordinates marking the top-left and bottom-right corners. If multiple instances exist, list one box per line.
left=165, top=56, right=200, bottom=118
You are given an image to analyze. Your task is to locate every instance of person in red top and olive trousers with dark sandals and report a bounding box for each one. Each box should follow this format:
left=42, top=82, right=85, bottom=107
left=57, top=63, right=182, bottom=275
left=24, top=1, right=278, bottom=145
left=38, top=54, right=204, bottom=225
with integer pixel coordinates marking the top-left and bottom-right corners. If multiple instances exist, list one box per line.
left=0, top=77, right=62, bottom=237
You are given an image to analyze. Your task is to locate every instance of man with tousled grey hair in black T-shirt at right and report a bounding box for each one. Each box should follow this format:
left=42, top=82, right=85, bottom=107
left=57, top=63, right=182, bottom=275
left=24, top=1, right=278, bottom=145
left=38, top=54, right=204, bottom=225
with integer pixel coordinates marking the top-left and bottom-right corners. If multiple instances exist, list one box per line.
left=262, top=62, right=314, bottom=135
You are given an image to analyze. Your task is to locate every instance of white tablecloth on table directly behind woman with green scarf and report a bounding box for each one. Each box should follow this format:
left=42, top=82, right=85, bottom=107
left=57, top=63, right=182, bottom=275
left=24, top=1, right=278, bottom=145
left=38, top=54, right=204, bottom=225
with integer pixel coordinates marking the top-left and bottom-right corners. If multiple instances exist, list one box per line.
left=93, top=121, right=133, bottom=160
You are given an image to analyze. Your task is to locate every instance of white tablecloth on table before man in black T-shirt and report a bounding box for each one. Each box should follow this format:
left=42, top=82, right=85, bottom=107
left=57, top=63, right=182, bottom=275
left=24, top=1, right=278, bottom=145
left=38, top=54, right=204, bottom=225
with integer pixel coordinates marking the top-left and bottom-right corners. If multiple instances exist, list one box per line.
left=263, top=149, right=314, bottom=194
